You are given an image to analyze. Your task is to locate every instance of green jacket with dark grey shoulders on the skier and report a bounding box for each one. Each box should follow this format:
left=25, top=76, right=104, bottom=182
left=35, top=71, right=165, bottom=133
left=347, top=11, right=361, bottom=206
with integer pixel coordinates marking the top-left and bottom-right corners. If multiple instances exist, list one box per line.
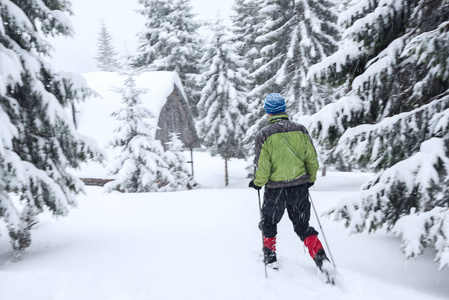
left=254, top=114, right=318, bottom=188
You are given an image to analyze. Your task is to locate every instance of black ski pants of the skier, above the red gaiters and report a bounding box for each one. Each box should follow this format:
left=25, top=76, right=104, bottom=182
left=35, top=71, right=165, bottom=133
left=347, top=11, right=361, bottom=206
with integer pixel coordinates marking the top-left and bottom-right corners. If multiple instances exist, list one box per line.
left=261, top=184, right=318, bottom=241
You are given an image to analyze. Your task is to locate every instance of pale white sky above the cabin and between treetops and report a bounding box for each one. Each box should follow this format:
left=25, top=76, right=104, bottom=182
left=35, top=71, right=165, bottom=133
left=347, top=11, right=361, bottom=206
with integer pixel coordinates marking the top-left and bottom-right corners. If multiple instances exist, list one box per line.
left=50, top=0, right=234, bottom=74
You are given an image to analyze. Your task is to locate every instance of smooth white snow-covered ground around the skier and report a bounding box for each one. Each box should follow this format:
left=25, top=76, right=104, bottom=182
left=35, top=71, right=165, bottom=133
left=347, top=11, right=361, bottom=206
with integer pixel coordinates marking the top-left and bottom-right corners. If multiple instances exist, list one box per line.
left=0, top=152, right=449, bottom=300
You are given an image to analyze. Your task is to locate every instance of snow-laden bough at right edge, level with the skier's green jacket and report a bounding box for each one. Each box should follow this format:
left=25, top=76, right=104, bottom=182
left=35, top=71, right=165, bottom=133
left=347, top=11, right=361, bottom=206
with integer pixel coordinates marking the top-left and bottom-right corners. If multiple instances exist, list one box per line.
left=335, top=95, right=449, bottom=170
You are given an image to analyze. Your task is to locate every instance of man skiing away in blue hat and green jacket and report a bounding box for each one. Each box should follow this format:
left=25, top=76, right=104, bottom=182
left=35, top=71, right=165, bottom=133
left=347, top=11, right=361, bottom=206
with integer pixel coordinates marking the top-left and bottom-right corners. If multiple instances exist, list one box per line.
left=249, top=93, right=334, bottom=283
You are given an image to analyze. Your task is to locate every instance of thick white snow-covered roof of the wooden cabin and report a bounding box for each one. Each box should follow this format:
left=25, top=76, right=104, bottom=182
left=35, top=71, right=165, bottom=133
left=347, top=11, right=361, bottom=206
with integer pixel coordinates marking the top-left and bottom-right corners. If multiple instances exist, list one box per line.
left=72, top=71, right=187, bottom=178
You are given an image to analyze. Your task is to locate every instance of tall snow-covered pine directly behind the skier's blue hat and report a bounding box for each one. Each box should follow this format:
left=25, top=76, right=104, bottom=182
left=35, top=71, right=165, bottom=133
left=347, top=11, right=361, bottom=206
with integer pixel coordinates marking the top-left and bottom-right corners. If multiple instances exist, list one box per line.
left=246, top=0, right=339, bottom=159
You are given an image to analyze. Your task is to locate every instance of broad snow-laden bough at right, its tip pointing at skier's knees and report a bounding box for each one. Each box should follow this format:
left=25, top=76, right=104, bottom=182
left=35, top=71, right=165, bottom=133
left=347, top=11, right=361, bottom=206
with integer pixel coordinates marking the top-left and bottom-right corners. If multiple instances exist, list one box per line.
left=329, top=138, right=449, bottom=232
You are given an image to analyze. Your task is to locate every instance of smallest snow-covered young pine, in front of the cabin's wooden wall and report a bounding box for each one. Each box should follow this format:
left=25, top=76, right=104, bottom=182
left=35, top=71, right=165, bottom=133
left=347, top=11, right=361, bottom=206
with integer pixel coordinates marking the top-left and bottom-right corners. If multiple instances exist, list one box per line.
left=163, top=133, right=191, bottom=191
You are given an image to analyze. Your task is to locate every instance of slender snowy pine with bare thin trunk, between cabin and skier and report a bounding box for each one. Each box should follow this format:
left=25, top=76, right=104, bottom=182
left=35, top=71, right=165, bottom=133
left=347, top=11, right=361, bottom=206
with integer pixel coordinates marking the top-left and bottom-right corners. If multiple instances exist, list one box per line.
left=197, top=20, right=247, bottom=186
